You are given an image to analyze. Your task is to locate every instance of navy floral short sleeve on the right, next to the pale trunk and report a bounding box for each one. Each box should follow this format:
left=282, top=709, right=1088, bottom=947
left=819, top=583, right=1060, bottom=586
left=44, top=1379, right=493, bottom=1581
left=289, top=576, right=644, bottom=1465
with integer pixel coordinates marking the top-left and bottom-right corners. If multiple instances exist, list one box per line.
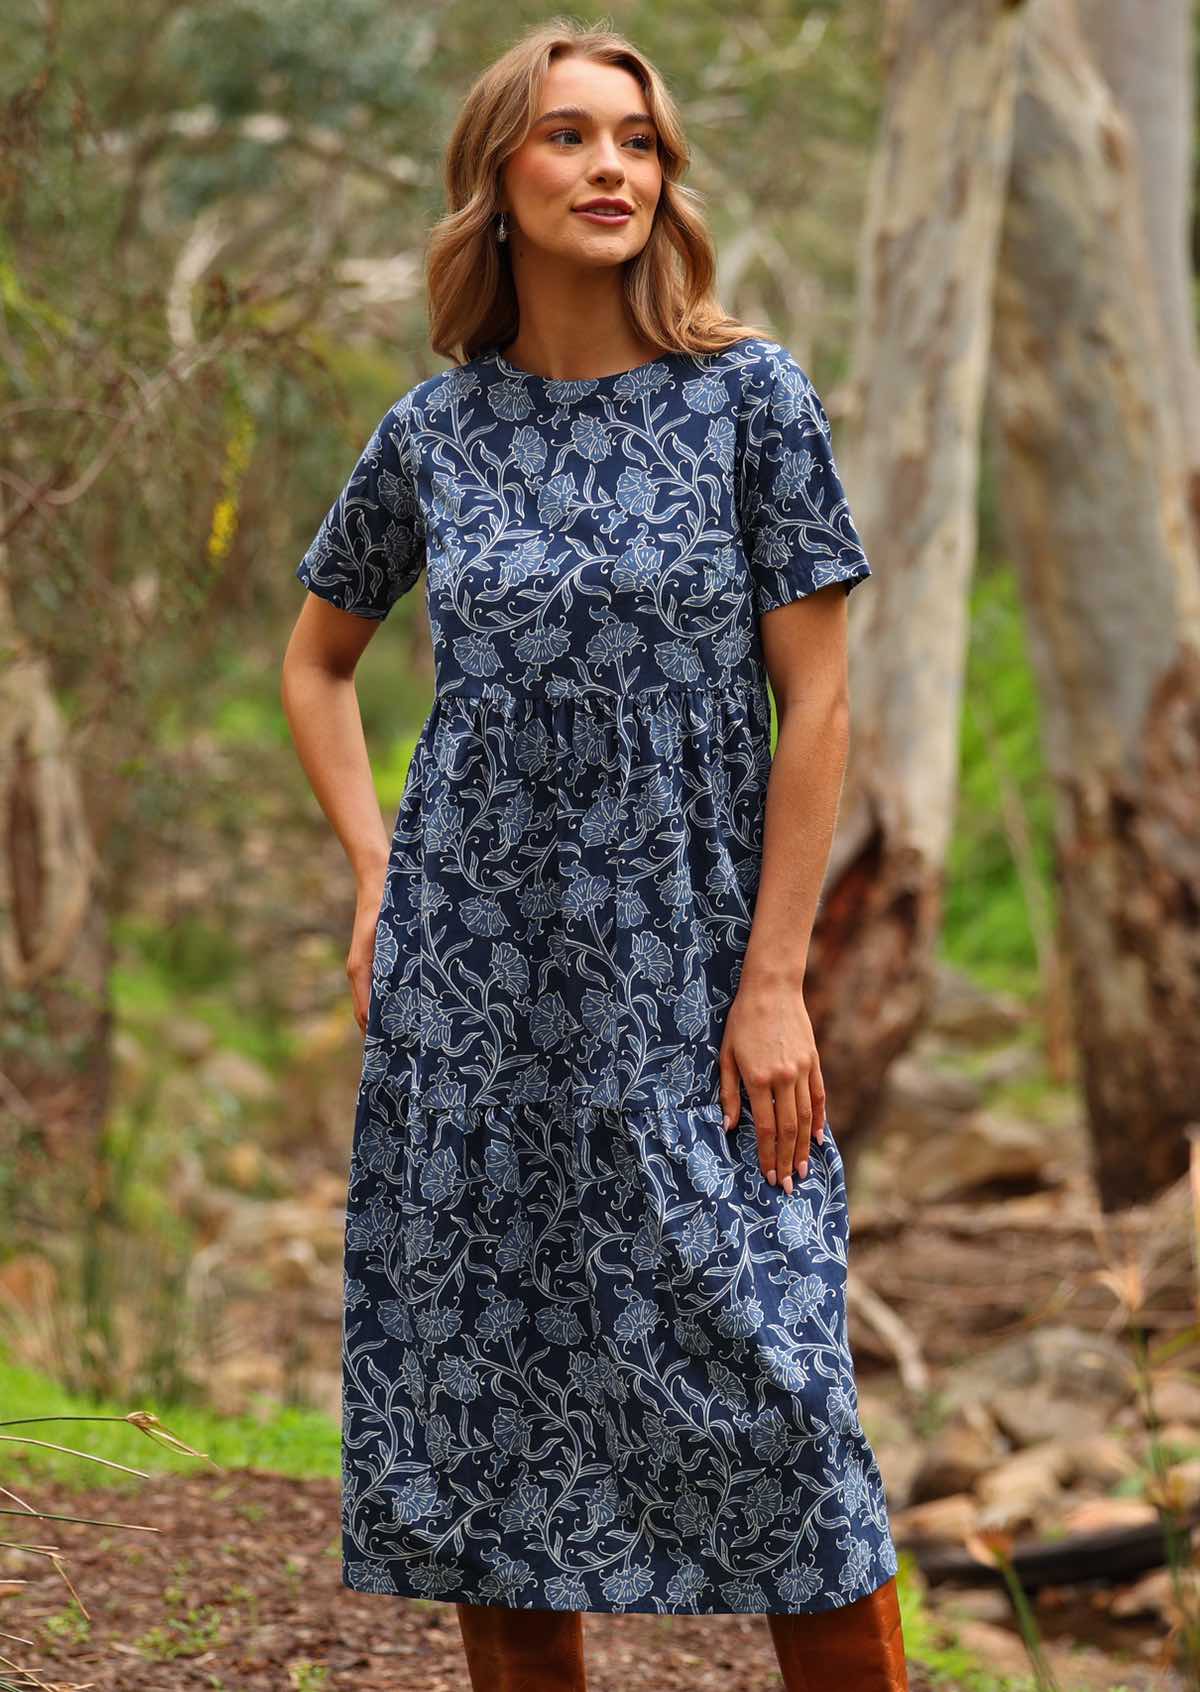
left=740, top=349, right=872, bottom=616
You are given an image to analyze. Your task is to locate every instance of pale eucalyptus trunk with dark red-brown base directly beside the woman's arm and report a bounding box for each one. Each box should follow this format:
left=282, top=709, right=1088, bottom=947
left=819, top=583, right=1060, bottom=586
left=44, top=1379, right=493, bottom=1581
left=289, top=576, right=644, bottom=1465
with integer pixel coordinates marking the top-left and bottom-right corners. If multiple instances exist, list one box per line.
left=809, top=0, right=1021, bottom=1164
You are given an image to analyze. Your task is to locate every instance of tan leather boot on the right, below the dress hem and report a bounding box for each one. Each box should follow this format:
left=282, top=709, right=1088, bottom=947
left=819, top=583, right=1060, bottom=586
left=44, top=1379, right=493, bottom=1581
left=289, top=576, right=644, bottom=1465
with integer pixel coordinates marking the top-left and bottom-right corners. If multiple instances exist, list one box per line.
left=767, top=1575, right=909, bottom=1692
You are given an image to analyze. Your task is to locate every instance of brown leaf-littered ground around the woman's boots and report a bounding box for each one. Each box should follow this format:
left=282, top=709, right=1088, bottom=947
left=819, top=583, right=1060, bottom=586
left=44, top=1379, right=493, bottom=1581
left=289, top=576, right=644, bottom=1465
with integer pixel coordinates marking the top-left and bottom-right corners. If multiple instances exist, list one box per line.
left=0, top=1470, right=933, bottom=1692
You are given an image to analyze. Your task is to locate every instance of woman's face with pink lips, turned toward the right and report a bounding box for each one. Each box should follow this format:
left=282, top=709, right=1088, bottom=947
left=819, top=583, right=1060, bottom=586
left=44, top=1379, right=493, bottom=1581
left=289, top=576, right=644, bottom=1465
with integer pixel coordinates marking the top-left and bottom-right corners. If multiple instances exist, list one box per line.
left=501, top=58, right=662, bottom=266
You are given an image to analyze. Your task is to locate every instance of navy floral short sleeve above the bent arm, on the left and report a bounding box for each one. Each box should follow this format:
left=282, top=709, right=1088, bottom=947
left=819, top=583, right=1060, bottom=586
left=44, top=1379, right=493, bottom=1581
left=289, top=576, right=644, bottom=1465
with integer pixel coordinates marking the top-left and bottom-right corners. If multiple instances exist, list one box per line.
left=296, top=399, right=425, bottom=621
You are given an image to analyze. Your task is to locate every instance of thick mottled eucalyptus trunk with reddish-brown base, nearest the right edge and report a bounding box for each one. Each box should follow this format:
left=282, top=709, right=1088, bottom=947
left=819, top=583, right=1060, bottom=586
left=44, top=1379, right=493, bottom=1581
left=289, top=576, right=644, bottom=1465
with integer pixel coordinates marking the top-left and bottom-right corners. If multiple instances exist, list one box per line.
left=992, top=0, right=1200, bottom=1210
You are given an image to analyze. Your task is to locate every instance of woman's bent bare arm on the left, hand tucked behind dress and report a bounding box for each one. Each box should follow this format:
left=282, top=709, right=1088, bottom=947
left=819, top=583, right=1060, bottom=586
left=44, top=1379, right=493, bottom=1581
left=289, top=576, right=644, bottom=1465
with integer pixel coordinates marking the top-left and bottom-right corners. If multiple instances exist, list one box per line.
left=281, top=592, right=391, bottom=1034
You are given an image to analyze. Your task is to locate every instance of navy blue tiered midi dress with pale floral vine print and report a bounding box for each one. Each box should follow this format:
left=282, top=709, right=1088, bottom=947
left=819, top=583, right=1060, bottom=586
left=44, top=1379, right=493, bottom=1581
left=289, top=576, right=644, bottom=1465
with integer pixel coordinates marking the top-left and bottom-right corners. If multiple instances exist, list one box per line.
left=296, top=337, right=897, bottom=1614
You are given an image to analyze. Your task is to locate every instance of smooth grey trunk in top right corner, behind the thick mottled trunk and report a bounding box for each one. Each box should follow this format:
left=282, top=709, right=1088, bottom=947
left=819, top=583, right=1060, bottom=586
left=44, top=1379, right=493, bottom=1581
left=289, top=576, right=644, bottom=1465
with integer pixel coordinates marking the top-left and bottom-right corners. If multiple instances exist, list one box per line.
left=1080, top=0, right=1200, bottom=535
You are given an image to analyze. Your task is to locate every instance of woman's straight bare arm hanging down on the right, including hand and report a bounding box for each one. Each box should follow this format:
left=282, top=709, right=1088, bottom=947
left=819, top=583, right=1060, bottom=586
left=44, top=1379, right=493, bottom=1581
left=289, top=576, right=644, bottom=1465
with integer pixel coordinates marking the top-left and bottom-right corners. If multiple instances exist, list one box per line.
left=710, top=582, right=850, bottom=1193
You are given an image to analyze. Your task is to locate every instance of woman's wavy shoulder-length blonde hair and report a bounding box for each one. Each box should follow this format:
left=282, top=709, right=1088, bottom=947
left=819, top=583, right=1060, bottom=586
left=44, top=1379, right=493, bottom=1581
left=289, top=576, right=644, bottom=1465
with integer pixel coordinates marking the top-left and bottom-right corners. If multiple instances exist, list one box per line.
left=425, top=17, right=770, bottom=362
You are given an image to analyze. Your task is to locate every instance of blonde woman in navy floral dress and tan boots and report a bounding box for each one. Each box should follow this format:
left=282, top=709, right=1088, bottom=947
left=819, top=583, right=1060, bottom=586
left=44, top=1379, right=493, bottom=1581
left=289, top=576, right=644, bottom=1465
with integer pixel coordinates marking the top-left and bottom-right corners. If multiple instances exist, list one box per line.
left=284, top=20, right=907, bottom=1692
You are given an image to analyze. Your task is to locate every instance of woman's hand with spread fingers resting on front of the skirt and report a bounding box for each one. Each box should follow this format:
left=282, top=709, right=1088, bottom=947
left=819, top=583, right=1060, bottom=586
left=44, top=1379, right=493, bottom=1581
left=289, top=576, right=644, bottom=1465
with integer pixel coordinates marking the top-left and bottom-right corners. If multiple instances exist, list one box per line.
left=721, top=975, right=826, bottom=1193
